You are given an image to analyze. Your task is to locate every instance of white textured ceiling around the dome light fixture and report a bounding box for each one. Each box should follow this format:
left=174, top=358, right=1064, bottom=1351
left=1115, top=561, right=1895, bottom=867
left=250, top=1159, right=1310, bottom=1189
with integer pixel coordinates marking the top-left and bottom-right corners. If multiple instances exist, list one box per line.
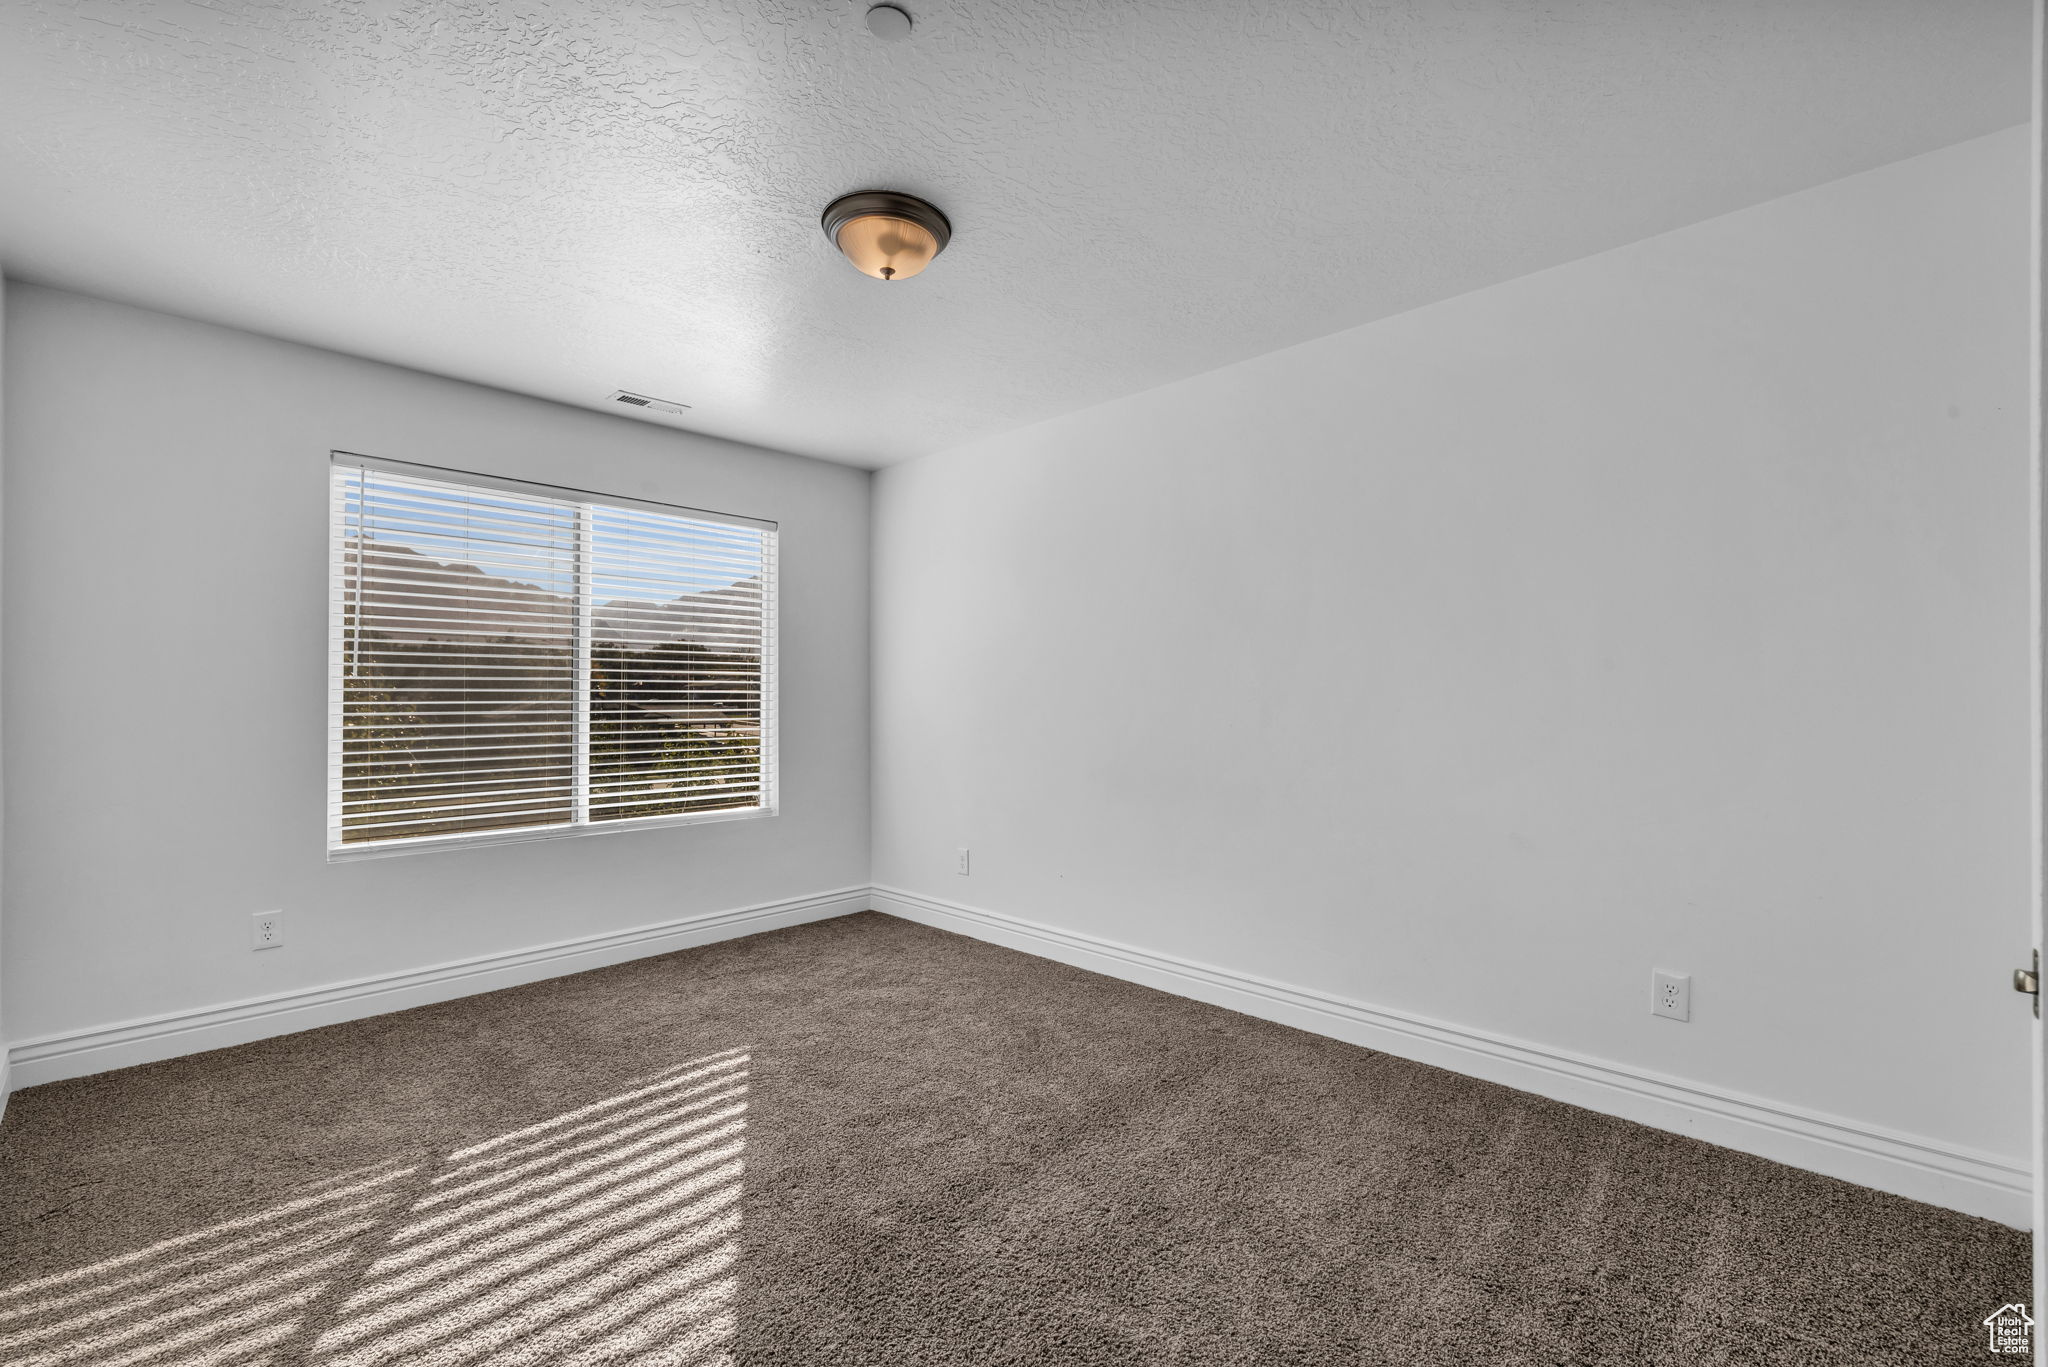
left=0, top=0, right=2030, bottom=465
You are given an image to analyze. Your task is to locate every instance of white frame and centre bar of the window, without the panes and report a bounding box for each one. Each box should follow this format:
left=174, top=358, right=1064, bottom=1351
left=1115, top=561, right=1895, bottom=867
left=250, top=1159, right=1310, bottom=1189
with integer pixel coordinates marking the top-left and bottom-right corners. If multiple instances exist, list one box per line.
left=326, top=451, right=782, bottom=863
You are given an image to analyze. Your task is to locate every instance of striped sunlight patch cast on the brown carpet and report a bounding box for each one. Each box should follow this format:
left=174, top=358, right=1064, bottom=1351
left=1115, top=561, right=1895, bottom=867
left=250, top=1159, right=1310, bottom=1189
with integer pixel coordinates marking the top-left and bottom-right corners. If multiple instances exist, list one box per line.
left=0, top=1049, right=750, bottom=1367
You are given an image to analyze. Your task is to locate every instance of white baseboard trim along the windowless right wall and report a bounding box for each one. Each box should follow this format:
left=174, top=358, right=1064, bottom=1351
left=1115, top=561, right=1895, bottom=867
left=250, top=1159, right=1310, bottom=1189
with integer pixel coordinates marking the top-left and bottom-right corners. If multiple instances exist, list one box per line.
left=870, top=887, right=2034, bottom=1230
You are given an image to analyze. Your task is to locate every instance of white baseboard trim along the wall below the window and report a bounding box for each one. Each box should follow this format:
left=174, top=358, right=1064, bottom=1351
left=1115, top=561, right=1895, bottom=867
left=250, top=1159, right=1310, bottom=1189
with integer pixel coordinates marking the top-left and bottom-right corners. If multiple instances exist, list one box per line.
left=0, top=887, right=868, bottom=1099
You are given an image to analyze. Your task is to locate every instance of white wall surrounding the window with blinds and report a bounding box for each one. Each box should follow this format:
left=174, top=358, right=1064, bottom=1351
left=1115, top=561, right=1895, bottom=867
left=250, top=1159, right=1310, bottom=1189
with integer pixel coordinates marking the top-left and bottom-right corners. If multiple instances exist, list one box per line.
left=0, top=283, right=870, bottom=1062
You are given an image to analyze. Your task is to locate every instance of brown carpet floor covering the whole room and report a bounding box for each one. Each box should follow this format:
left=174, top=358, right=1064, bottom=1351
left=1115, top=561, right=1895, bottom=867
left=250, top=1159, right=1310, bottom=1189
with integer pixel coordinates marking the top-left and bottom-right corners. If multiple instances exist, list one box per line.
left=0, top=914, right=2030, bottom=1367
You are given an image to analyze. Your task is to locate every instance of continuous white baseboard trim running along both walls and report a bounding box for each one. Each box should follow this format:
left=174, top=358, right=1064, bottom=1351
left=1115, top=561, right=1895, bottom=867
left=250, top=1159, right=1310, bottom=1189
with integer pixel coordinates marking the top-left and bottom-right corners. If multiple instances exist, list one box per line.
left=12, top=887, right=2034, bottom=1230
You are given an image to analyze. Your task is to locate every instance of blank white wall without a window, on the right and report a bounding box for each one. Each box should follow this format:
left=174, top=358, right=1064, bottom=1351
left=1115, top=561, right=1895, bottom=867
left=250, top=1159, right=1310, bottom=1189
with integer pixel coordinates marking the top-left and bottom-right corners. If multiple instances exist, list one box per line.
left=874, top=129, right=2030, bottom=1188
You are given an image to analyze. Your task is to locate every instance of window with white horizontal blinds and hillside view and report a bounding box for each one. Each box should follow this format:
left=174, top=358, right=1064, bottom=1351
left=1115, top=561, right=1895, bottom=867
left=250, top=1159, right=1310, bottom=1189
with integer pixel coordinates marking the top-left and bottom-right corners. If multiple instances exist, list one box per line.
left=328, top=453, right=776, bottom=857
